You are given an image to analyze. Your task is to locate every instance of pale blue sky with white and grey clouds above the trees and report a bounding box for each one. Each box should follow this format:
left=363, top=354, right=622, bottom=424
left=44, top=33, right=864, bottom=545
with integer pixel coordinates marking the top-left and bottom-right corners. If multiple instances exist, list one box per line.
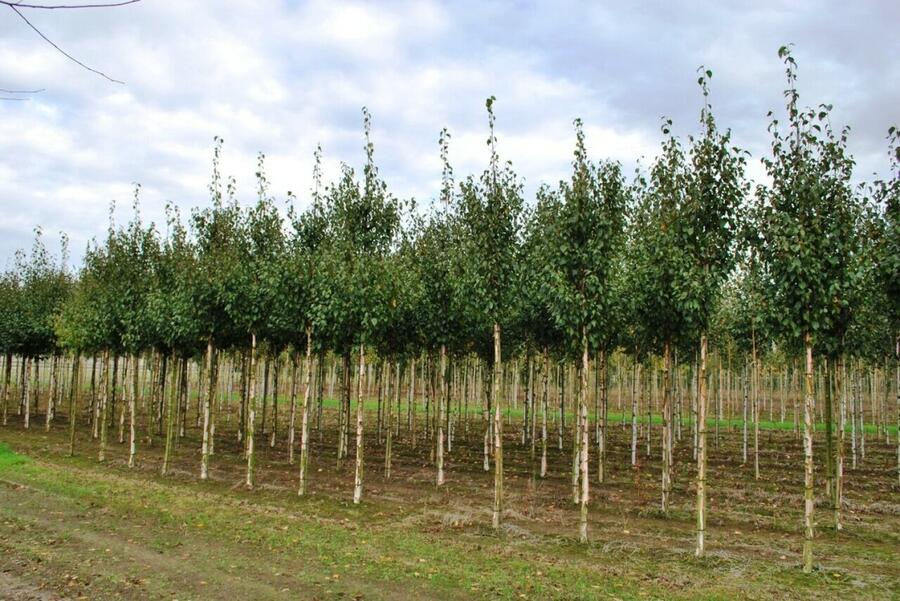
left=0, top=0, right=900, bottom=263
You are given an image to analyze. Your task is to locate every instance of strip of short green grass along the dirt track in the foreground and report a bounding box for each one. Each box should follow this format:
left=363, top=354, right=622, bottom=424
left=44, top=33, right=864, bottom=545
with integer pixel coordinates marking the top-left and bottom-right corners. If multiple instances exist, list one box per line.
left=0, top=445, right=676, bottom=599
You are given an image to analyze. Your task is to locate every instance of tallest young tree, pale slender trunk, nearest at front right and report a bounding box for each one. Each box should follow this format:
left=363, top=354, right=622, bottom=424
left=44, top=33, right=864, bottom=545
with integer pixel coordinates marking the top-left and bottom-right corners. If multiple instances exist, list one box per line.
left=758, top=46, right=855, bottom=572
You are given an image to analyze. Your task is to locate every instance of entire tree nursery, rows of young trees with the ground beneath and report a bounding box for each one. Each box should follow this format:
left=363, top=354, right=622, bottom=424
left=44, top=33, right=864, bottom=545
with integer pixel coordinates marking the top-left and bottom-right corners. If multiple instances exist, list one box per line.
left=0, top=32, right=900, bottom=601
